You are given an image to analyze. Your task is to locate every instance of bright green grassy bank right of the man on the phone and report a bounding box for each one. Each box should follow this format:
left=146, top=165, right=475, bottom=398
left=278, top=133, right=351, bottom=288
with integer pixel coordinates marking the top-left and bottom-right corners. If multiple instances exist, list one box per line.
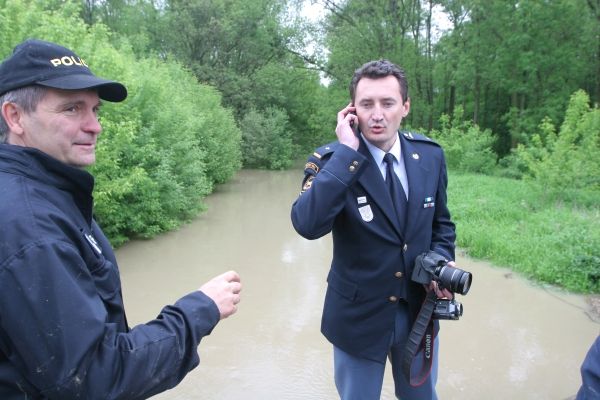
left=448, top=173, right=600, bottom=293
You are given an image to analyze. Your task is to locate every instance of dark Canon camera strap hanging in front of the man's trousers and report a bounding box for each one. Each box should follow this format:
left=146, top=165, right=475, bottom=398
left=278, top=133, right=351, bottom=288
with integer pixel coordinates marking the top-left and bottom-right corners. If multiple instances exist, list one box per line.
left=402, top=290, right=437, bottom=386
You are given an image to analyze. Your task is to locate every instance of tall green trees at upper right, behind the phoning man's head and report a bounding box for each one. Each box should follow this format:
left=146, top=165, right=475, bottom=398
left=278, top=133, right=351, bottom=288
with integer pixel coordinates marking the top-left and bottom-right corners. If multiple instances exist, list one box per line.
left=323, top=0, right=600, bottom=157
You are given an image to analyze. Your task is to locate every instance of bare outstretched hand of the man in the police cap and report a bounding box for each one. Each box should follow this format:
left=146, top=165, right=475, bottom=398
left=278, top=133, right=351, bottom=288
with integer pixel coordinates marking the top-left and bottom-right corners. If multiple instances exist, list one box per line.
left=200, top=271, right=242, bottom=319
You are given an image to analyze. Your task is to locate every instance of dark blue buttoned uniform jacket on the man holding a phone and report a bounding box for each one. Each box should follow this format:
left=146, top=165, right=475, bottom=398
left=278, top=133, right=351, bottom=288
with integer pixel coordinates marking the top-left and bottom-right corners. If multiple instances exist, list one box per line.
left=291, top=133, right=455, bottom=363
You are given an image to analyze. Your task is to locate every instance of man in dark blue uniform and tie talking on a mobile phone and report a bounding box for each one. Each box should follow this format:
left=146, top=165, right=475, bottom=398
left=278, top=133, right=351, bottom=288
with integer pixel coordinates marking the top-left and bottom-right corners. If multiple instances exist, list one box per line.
left=291, top=60, right=455, bottom=400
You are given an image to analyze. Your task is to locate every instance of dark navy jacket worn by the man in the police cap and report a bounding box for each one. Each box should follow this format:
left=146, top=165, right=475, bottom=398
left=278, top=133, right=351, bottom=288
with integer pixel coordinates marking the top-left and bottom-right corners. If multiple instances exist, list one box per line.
left=0, top=144, right=219, bottom=400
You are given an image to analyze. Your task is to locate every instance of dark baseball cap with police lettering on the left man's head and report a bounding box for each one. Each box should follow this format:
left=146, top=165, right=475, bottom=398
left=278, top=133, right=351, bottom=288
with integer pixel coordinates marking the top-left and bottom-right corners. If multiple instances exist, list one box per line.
left=0, top=39, right=127, bottom=102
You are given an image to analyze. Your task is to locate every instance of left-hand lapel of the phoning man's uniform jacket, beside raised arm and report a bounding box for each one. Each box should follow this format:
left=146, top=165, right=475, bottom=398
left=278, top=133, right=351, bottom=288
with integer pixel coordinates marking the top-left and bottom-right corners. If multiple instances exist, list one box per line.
left=358, top=137, right=404, bottom=239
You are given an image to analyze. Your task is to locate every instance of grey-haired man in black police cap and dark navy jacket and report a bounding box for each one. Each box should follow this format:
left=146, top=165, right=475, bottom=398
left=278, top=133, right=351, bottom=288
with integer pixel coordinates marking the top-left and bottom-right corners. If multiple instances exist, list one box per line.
left=0, top=40, right=241, bottom=400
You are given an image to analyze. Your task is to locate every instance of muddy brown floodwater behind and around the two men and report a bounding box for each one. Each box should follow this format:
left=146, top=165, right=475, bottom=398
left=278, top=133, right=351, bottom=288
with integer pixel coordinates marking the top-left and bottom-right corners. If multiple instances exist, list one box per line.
left=117, top=170, right=600, bottom=400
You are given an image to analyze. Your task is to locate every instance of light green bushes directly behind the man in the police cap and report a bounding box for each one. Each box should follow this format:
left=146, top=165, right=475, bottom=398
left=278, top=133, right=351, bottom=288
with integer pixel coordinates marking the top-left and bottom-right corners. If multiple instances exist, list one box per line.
left=0, top=0, right=241, bottom=244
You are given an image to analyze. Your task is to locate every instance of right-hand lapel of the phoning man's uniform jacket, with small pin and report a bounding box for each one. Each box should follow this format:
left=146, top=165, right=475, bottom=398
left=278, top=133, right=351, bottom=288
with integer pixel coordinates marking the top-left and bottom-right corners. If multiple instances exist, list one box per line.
left=399, top=133, right=429, bottom=236
